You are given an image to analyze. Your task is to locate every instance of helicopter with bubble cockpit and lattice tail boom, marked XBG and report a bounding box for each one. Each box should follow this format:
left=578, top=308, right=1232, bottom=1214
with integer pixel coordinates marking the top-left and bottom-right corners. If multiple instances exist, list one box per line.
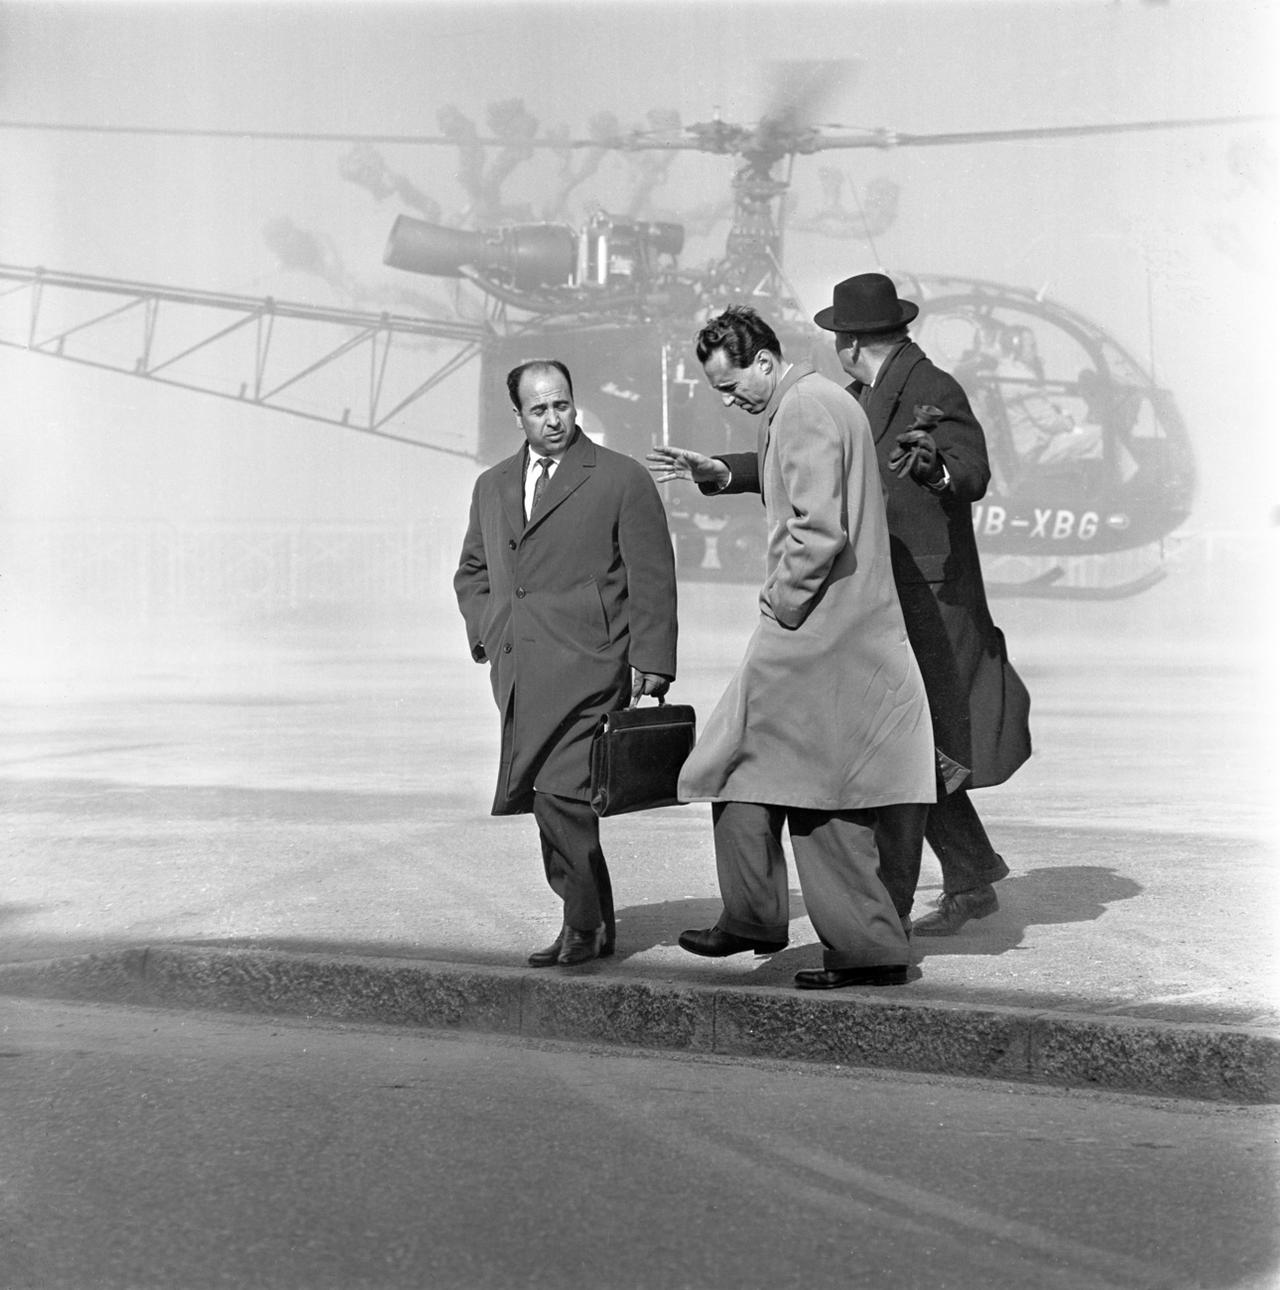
left=0, top=63, right=1265, bottom=599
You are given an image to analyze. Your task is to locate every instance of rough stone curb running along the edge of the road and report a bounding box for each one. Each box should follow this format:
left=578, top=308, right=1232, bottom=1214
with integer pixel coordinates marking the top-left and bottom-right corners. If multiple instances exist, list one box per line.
left=0, top=946, right=1280, bottom=1103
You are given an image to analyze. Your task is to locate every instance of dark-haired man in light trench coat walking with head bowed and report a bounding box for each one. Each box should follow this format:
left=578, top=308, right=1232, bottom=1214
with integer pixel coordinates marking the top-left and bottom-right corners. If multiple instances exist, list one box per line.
left=649, top=306, right=934, bottom=989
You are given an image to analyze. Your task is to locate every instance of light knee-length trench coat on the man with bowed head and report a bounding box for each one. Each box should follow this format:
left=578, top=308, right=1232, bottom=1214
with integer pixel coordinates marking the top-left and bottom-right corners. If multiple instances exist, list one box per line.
left=680, top=364, right=935, bottom=811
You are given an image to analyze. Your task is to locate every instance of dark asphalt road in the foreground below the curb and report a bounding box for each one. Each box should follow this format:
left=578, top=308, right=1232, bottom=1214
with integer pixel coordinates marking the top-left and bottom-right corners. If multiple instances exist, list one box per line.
left=0, top=1000, right=1280, bottom=1290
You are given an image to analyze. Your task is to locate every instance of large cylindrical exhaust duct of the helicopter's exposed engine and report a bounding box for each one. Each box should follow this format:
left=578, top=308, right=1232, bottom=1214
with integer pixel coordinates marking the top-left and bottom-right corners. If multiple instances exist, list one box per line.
left=382, top=215, right=578, bottom=292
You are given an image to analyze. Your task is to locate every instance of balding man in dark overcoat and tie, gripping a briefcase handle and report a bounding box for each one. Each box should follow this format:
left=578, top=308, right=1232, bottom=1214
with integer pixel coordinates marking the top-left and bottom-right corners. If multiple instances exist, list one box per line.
left=453, top=360, right=676, bottom=968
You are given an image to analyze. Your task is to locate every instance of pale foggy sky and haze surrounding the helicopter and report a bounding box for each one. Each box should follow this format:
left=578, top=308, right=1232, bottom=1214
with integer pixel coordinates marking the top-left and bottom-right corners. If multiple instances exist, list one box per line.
left=0, top=0, right=1280, bottom=675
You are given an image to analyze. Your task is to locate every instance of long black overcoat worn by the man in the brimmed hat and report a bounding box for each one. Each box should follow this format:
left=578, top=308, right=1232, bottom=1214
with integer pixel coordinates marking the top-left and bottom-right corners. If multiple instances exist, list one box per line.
left=724, top=341, right=1031, bottom=788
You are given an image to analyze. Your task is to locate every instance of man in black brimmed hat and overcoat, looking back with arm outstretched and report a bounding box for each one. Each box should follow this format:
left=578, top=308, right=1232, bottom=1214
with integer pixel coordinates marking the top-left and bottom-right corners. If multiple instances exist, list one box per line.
left=650, top=273, right=1031, bottom=937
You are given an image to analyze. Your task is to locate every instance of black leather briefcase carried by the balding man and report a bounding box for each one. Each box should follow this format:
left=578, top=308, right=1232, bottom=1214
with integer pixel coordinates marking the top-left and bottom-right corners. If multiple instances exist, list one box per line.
left=591, top=699, right=697, bottom=815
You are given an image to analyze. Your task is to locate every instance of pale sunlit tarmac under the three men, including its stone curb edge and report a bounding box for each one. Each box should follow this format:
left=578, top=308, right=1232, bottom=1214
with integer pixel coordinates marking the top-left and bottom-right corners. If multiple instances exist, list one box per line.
left=0, top=551, right=1280, bottom=1102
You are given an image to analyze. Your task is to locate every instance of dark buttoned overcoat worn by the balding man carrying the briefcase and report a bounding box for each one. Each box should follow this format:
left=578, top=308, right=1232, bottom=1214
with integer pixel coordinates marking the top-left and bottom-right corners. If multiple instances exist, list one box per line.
left=453, top=430, right=676, bottom=815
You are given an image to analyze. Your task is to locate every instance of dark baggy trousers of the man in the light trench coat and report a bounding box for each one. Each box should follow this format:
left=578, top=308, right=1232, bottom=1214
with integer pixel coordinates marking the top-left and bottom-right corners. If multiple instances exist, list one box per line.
left=711, top=802, right=911, bottom=969
